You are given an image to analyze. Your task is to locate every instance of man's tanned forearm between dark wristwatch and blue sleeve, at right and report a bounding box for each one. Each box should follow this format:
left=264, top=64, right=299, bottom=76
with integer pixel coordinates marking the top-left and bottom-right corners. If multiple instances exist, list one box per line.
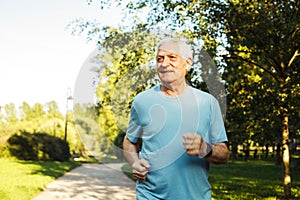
left=205, top=143, right=230, bottom=164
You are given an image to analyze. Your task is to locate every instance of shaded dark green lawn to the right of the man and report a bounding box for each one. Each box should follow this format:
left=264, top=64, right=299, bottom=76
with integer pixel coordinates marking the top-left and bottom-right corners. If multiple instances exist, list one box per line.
left=123, top=160, right=300, bottom=200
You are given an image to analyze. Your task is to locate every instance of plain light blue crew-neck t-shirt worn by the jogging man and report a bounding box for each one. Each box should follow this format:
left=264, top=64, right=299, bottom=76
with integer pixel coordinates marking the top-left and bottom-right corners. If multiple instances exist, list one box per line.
left=126, top=86, right=227, bottom=200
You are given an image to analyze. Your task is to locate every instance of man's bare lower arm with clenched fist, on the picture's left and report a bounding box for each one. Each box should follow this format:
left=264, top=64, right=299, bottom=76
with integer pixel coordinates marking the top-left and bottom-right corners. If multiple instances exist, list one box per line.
left=123, top=136, right=150, bottom=181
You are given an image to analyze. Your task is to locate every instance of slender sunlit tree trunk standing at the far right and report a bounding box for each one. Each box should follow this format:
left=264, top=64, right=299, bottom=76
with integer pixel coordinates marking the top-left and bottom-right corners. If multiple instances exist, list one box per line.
left=282, top=113, right=291, bottom=197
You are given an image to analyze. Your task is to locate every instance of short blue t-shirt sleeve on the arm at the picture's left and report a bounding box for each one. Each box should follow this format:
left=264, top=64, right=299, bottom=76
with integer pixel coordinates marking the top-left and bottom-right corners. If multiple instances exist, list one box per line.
left=126, top=101, right=142, bottom=143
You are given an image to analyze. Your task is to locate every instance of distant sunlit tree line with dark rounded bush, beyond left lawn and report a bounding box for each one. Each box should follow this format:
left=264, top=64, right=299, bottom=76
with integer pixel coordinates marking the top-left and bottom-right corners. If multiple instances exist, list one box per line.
left=0, top=101, right=84, bottom=161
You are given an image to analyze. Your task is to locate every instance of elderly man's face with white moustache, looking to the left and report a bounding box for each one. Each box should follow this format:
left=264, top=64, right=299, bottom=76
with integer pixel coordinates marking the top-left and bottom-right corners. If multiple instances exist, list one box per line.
left=156, top=43, right=188, bottom=83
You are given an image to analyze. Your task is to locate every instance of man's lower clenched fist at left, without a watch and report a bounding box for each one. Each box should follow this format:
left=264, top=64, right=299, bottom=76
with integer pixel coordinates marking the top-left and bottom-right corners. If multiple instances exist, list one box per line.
left=132, top=159, right=150, bottom=181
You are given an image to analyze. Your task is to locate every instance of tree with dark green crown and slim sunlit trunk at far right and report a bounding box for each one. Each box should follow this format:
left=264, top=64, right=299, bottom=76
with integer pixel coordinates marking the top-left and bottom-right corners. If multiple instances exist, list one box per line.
left=220, top=0, right=300, bottom=196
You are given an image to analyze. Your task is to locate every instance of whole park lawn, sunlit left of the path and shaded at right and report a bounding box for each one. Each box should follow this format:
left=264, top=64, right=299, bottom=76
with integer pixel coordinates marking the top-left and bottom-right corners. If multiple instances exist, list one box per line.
left=0, top=158, right=300, bottom=200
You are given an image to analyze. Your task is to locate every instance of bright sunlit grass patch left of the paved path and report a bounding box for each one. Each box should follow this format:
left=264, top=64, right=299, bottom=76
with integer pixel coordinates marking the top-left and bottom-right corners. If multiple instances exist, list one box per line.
left=0, top=158, right=80, bottom=200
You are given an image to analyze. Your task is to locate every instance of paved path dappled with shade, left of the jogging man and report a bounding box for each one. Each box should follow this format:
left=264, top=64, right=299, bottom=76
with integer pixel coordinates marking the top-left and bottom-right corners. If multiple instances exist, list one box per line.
left=34, top=163, right=135, bottom=200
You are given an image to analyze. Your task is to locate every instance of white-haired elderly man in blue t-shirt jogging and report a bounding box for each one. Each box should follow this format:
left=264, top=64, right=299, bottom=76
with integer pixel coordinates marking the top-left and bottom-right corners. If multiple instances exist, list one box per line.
left=123, top=38, right=229, bottom=200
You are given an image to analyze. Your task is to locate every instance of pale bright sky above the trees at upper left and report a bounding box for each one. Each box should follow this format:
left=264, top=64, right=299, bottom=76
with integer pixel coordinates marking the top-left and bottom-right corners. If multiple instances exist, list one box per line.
left=0, top=0, right=120, bottom=112
